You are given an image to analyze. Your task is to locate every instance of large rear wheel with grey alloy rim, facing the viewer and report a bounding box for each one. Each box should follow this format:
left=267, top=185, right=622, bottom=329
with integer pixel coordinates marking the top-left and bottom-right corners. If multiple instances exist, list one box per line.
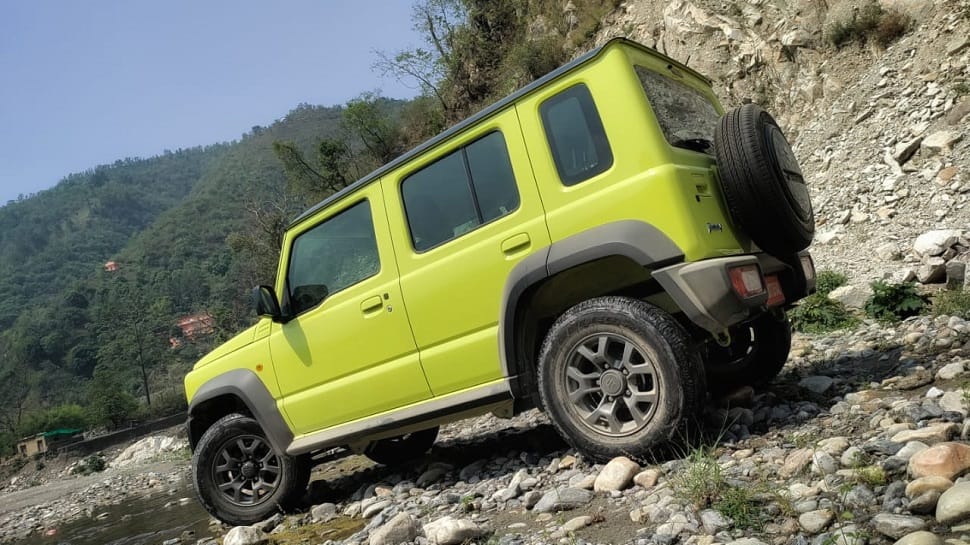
left=538, top=296, right=706, bottom=461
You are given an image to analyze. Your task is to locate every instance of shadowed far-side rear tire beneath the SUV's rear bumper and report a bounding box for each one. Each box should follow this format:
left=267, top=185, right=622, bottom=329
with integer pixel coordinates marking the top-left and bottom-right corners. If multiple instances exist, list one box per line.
left=704, top=313, right=792, bottom=393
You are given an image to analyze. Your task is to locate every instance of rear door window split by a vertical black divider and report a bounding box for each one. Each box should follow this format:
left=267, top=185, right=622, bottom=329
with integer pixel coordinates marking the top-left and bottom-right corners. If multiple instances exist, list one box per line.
left=401, top=132, right=519, bottom=252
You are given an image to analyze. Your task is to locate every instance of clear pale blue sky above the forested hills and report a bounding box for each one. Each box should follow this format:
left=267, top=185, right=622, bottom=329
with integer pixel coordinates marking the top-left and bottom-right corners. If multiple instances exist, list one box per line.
left=0, top=0, right=420, bottom=205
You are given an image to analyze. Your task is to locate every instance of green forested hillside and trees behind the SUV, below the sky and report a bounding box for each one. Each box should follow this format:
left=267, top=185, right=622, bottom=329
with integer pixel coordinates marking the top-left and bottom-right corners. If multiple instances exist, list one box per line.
left=0, top=0, right=616, bottom=454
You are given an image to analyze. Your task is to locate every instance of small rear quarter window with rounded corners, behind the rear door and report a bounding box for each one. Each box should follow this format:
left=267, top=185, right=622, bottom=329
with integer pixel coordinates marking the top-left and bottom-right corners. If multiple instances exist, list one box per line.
left=539, top=84, right=613, bottom=185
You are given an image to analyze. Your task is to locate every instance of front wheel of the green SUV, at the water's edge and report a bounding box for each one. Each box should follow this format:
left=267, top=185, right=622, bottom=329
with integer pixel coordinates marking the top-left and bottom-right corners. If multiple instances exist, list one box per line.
left=192, top=413, right=310, bottom=526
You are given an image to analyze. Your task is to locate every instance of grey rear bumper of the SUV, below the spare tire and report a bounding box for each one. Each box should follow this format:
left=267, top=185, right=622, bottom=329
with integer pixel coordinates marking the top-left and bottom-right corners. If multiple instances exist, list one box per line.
left=653, top=250, right=815, bottom=335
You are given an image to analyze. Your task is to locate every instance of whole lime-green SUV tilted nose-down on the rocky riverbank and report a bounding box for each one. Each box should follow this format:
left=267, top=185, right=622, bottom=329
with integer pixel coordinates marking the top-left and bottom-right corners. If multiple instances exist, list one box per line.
left=185, top=39, right=815, bottom=524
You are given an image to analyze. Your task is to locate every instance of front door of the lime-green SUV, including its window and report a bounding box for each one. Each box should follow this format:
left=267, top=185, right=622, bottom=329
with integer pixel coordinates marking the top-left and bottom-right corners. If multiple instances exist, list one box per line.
left=270, top=182, right=431, bottom=435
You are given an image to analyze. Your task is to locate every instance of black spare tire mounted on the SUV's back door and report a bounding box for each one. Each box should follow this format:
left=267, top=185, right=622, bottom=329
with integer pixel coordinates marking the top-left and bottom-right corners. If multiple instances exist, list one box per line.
left=714, top=104, right=815, bottom=255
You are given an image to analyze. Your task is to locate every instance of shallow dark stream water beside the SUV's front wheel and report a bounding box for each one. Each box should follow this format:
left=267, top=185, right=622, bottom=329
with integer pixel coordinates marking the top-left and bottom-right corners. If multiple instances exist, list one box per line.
left=27, top=483, right=213, bottom=545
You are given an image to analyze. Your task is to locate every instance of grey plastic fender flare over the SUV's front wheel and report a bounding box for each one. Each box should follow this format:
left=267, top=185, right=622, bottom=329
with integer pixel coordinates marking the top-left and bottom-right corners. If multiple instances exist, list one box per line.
left=186, top=369, right=293, bottom=453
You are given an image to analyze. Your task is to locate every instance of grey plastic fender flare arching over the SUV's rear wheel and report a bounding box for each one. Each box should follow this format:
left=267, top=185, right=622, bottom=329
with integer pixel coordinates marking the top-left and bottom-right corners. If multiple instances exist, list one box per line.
left=499, top=220, right=684, bottom=394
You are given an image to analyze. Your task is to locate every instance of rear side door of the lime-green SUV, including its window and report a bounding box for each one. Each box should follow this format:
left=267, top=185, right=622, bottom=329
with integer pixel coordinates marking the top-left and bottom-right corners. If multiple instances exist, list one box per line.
left=382, top=109, right=549, bottom=396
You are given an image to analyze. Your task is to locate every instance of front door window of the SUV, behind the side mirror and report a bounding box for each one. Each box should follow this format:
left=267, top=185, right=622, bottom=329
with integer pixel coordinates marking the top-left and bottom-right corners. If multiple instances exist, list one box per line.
left=286, top=200, right=381, bottom=314
